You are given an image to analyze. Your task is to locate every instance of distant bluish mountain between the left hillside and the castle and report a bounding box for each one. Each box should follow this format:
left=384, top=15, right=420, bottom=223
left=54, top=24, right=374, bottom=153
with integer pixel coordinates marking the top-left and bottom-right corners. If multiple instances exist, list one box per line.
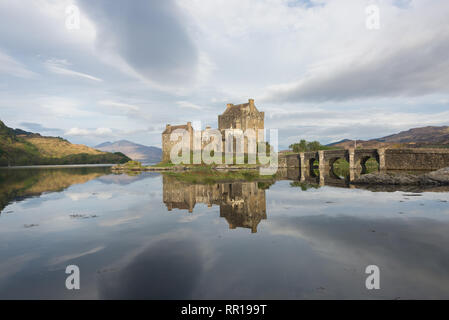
left=95, top=140, right=162, bottom=163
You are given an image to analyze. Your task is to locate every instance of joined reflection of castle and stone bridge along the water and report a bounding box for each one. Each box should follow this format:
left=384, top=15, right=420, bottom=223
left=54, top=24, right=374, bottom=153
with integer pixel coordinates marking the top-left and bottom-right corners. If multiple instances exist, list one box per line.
left=162, top=168, right=449, bottom=233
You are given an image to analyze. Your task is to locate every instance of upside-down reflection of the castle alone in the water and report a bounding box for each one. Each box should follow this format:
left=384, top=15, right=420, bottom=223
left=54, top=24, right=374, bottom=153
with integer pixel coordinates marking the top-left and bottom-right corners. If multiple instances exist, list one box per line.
left=163, top=176, right=267, bottom=233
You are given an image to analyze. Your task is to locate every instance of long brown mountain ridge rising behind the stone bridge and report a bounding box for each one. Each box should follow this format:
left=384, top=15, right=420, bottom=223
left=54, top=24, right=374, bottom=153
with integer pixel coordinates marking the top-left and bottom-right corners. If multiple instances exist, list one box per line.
left=328, top=126, right=449, bottom=148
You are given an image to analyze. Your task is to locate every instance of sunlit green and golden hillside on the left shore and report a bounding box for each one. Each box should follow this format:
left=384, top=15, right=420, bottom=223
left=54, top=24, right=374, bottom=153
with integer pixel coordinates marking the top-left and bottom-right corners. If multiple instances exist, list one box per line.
left=0, top=121, right=130, bottom=166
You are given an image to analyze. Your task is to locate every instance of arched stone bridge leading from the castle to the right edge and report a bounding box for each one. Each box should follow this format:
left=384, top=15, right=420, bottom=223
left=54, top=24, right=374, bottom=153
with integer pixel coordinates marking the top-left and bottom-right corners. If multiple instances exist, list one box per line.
left=279, top=148, right=449, bottom=177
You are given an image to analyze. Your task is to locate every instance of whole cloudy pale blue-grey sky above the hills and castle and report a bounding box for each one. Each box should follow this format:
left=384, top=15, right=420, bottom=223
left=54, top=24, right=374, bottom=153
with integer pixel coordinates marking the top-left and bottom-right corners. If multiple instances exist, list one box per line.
left=0, top=0, right=449, bottom=149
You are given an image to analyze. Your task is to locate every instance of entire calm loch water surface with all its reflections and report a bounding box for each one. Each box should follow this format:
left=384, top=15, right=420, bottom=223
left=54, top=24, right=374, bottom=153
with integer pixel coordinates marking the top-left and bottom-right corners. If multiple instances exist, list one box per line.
left=0, top=167, right=449, bottom=299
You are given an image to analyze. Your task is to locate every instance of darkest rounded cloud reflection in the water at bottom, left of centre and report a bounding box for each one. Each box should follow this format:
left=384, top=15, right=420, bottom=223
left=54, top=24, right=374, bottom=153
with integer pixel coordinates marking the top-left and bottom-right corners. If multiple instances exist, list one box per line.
left=99, top=236, right=203, bottom=299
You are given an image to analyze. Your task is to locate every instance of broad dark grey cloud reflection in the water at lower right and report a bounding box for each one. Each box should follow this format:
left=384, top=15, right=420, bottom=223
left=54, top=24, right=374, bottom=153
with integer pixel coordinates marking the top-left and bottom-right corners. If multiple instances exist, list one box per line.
left=266, top=215, right=449, bottom=298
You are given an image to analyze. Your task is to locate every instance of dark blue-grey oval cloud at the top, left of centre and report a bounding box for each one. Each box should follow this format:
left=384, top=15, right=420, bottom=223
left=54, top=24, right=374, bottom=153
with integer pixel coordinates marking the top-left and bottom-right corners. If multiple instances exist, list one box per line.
left=78, top=0, right=199, bottom=86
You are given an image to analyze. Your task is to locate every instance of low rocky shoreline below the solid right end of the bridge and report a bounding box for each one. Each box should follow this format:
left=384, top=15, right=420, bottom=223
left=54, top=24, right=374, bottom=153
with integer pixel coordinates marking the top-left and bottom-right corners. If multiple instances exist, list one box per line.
left=351, top=167, right=449, bottom=186
